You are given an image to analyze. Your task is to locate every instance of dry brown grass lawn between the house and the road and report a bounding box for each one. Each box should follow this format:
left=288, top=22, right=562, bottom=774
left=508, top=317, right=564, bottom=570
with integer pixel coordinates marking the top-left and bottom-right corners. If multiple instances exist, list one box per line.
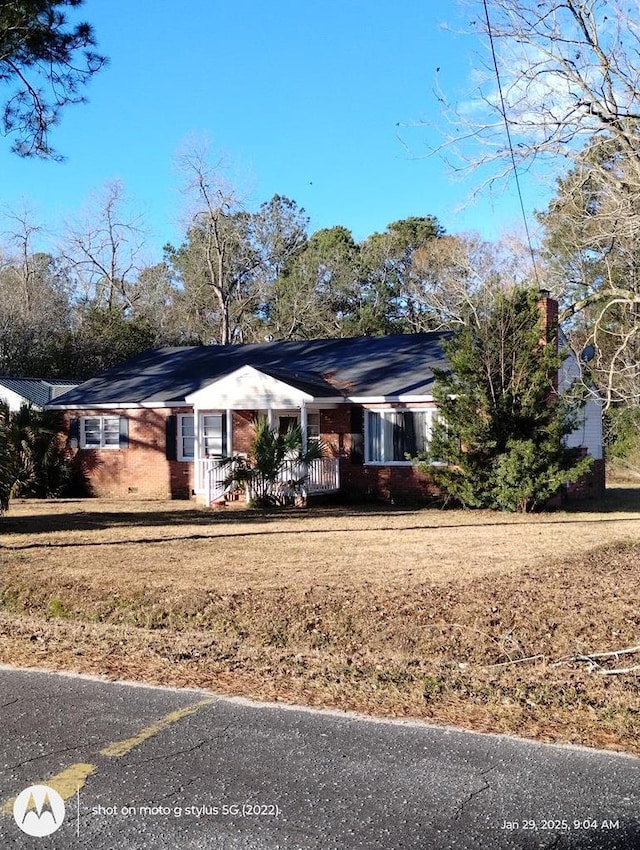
left=0, top=489, right=640, bottom=754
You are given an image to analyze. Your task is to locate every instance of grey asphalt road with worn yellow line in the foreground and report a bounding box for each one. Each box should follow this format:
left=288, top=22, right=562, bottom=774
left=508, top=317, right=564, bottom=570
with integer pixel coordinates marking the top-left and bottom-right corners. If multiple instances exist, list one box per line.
left=0, top=668, right=640, bottom=850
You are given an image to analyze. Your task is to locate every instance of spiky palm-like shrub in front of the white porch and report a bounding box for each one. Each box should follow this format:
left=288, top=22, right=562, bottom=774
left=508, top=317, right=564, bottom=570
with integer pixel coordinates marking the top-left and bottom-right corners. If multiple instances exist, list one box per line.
left=221, top=417, right=326, bottom=507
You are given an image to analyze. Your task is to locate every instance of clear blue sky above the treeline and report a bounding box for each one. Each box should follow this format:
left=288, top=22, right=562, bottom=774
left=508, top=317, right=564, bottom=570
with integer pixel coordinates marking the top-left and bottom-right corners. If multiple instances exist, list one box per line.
left=0, top=0, right=546, bottom=259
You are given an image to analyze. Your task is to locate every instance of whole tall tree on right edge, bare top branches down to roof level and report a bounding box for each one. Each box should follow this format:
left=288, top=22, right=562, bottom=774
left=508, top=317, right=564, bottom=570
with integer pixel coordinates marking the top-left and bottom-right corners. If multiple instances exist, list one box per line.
left=439, top=0, right=640, bottom=403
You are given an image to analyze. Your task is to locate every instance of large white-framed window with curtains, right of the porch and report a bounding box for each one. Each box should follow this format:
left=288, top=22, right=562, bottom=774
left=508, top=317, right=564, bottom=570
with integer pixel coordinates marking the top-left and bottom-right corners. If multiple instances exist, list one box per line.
left=365, top=410, right=434, bottom=463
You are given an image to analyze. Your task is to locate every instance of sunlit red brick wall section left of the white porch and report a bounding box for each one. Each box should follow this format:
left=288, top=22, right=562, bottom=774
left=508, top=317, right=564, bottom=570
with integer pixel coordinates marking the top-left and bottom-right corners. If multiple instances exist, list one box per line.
left=67, top=408, right=193, bottom=499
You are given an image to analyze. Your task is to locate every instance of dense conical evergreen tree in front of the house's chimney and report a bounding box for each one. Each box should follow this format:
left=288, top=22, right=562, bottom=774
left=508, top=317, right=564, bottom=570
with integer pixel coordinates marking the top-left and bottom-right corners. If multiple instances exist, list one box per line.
left=419, top=288, right=591, bottom=511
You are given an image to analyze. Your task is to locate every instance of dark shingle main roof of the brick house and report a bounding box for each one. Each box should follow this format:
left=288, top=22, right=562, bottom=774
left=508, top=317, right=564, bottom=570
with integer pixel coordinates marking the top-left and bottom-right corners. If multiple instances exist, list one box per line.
left=48, top=331, right=451, bottom=407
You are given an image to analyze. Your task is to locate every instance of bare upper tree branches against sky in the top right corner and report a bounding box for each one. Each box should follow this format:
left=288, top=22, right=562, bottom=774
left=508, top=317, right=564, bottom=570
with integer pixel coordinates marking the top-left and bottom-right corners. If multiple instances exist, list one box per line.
left=443, top=0, right=640, bottom=178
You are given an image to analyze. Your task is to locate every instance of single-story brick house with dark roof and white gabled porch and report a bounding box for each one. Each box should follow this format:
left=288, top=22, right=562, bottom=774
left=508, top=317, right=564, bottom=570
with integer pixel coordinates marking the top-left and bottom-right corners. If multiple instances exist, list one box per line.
left=50, top=296, right=604, bottom=504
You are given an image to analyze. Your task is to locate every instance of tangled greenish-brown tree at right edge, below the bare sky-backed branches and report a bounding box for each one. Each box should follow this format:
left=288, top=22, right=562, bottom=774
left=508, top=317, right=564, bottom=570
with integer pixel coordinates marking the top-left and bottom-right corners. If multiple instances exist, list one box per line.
left=540, top=139, right=640, bottom=408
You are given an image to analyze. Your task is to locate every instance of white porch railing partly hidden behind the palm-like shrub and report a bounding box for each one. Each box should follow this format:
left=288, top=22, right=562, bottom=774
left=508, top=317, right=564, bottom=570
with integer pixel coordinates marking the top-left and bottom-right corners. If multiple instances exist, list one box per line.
left=198, top=457, right=340, bottom=505
